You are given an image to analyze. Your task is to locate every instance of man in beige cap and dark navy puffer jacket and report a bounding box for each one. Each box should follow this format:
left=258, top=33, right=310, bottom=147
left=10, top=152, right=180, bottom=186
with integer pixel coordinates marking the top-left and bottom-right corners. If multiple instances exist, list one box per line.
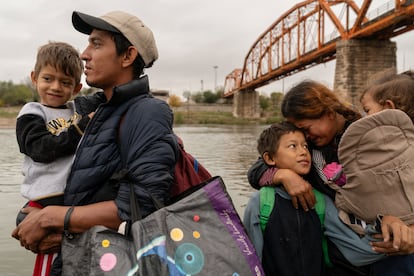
left=13, top=11, right=178, bottom=275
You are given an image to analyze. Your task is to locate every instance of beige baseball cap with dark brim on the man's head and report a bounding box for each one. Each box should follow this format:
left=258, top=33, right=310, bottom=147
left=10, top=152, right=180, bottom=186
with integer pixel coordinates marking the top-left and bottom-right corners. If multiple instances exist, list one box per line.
left=72, top=11, right=158, bottom=67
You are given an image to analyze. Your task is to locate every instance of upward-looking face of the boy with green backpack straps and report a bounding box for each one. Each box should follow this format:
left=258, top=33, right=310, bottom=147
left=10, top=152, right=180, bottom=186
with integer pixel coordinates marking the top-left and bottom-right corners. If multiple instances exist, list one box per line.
left=273, top=131, right=311, bottom=175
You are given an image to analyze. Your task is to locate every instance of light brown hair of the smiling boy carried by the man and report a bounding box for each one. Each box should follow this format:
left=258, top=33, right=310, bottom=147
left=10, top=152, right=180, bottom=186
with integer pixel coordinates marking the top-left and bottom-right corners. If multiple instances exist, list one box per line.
left=34, top=41, right=83, bottom=85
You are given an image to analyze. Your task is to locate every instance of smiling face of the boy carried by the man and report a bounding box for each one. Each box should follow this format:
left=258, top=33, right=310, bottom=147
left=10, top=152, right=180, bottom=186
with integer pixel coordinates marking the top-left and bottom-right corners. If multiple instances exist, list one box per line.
left=31, top=65, right=82, bottom=107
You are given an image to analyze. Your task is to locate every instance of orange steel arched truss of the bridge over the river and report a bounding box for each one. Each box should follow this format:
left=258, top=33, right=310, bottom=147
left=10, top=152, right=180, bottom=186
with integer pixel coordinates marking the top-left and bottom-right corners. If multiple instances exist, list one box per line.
left=224, top=0, right=414, bottom=97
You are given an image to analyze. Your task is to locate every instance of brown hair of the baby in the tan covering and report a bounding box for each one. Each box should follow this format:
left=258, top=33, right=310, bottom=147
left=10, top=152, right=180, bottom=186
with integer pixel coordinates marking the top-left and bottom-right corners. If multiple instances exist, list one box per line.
left=361, top=71, right=414, bottom=122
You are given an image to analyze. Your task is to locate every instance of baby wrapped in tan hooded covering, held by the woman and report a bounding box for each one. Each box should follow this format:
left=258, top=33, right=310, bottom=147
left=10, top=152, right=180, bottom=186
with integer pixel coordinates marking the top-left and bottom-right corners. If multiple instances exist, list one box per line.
left=324, top=70, right=414, bottom=234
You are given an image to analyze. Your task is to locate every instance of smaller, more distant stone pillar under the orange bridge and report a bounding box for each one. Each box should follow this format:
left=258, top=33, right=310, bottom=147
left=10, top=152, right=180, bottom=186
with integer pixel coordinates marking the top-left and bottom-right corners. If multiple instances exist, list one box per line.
left=233, top=90, right=260, bottom=118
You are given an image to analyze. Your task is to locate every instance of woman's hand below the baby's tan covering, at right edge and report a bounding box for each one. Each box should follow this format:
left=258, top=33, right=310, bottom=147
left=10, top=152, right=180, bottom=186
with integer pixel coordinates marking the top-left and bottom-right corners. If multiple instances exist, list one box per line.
left=371, top=216, right=414, bottom=255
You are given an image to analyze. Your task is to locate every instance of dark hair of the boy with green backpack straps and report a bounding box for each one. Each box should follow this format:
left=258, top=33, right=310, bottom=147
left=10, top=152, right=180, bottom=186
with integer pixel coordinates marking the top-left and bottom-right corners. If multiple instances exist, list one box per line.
left=257, top=121, right=303, bottom=156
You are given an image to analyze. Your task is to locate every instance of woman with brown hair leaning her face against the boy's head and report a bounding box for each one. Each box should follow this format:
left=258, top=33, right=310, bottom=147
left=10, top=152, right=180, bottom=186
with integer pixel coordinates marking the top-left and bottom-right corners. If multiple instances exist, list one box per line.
left=248, top=80, right=414, bottom=276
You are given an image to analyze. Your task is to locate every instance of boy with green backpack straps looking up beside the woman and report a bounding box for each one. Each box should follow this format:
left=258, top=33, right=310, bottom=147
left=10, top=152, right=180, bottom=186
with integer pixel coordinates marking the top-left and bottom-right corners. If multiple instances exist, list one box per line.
left=243, top=122, right=385, bottom=276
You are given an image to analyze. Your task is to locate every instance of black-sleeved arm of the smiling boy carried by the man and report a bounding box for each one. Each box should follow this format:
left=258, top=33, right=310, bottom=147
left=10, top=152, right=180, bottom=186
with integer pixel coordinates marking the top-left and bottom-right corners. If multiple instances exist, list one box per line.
left=16, top=114, right=90, bottom=163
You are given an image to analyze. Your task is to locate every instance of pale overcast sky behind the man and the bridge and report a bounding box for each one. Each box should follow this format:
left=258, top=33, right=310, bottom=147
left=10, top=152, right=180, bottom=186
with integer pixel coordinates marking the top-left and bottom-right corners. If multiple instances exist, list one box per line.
left=0, top=0, right=414, bottom=95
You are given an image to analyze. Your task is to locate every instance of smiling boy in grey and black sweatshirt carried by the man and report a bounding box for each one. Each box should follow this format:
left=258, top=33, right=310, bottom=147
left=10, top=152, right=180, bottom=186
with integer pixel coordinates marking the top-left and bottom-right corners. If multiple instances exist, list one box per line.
left=16, top=42, right=99, bottom=275
